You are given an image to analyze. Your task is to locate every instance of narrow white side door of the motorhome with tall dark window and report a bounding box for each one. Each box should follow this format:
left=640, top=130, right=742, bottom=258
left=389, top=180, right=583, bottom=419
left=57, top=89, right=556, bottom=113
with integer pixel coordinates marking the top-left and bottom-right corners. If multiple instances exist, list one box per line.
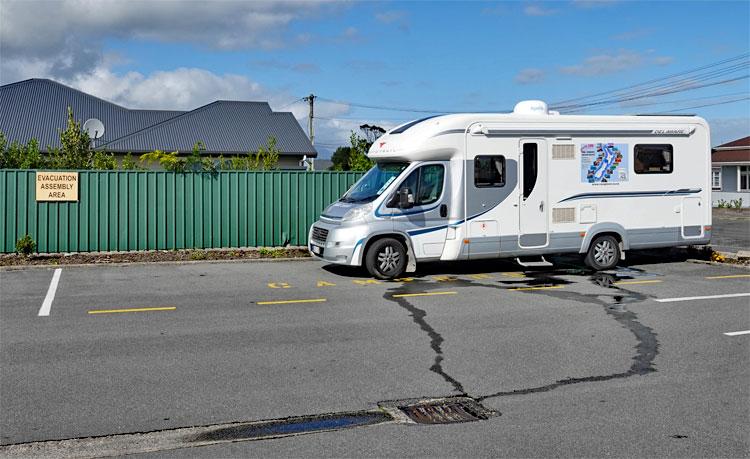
left=518, top=139, right=550, bottom=249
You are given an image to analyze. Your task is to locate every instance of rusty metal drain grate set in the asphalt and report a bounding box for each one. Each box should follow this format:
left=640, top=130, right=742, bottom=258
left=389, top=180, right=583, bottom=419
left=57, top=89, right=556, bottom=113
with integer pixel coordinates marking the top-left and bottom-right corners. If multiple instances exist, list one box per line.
left=398, top=397, right=496, bottom=424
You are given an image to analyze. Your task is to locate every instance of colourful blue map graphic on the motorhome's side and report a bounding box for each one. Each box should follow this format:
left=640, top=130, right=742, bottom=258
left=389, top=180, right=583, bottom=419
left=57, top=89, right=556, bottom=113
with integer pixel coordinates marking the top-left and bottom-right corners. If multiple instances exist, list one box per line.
left=581, top=143, right=628, bottom=185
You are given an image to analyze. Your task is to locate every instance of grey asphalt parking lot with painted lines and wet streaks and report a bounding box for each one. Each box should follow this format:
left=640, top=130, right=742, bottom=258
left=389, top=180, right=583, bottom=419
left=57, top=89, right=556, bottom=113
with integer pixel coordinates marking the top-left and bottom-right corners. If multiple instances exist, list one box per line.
left=0, top=252, right=750, bottom=457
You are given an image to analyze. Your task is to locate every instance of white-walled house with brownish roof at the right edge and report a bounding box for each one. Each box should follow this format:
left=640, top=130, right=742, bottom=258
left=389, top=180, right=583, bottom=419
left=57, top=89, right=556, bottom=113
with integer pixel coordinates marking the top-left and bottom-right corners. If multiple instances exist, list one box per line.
left=711, top=136, right=750, bottom=207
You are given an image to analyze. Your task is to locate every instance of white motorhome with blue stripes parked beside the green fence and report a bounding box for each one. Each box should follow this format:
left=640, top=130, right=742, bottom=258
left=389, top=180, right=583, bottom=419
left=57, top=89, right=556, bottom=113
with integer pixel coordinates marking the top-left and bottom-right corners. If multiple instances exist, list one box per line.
left=309, top=101, right=711, bottom=279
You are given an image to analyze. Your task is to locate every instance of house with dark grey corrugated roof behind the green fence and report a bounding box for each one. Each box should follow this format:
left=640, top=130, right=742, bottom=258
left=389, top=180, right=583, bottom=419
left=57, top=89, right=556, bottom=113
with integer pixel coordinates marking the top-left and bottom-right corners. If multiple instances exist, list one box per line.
left=0, top=78, right=317, bottom=169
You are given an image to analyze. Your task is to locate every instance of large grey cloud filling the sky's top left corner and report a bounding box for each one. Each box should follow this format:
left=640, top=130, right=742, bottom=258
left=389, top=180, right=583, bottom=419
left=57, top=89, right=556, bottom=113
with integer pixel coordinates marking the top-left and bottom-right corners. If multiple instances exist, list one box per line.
left=0, top=0, right=341, bottom=82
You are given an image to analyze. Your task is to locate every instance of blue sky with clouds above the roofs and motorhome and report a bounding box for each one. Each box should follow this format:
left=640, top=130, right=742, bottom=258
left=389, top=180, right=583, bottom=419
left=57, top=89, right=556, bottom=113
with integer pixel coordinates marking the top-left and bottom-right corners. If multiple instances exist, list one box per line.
left=0, top=0, right=750, bottom=156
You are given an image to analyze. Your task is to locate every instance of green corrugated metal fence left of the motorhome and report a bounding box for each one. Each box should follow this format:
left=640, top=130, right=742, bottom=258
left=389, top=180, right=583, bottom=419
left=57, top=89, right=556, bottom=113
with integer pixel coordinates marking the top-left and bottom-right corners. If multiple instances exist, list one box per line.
left=0, top=169, right=362, bottom=253
